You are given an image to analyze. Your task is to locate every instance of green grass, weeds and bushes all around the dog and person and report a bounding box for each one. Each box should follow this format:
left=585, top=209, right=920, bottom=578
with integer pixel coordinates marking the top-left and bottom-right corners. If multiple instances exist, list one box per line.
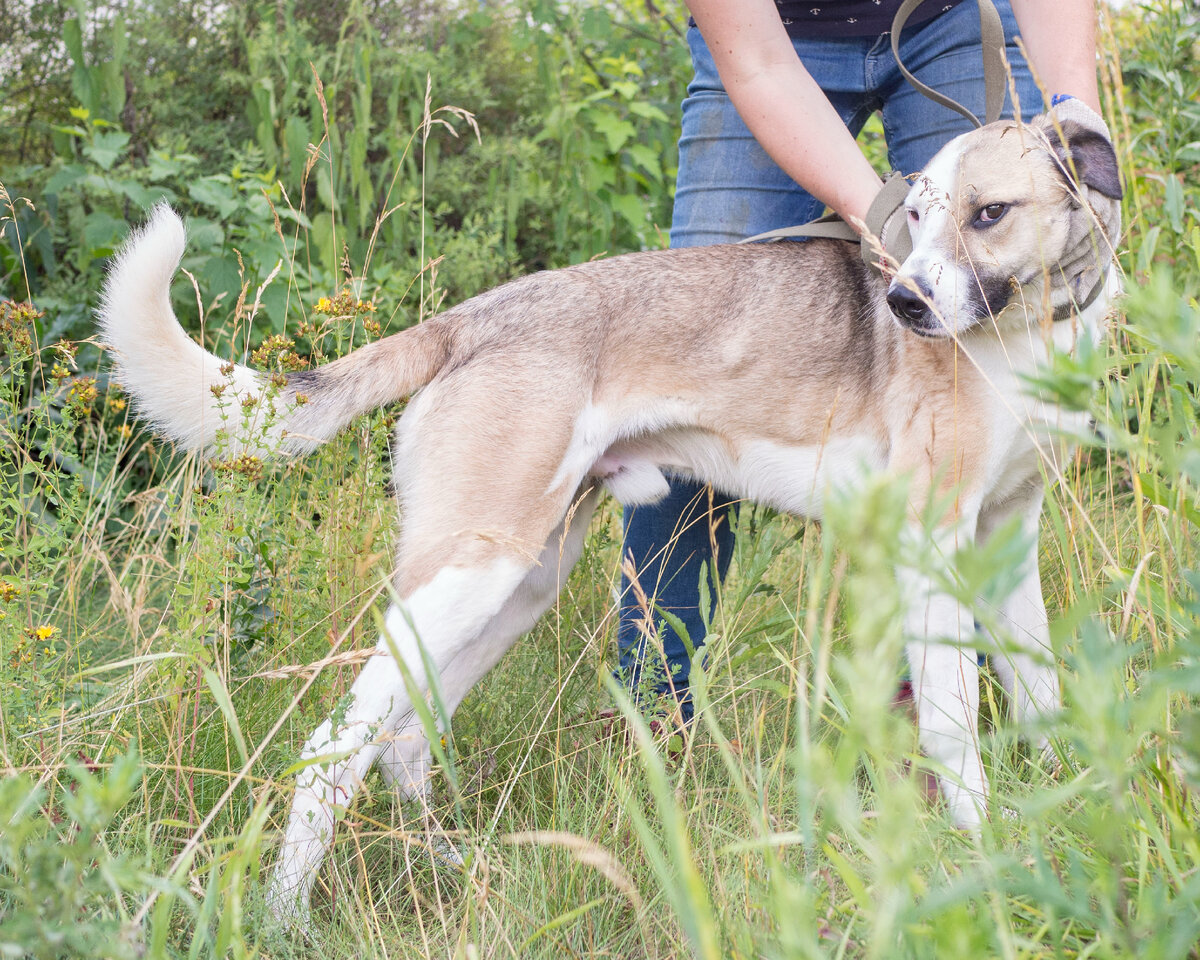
left=0, top=0, right=1200, bottom=960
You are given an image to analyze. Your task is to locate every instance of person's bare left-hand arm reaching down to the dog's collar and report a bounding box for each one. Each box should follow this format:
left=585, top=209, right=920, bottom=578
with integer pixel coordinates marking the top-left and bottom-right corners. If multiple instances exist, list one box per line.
left=688, top=0, right=881, bottom=229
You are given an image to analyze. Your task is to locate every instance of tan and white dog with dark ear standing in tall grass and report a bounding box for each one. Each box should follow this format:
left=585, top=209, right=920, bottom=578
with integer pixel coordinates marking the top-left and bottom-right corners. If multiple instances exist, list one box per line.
left=100, top=108, right=1122, bottom=918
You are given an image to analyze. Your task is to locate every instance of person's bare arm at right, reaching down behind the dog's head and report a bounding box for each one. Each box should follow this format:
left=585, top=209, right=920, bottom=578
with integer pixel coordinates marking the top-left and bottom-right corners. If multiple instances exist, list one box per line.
left=1012, top=0, right=1100, bottom=113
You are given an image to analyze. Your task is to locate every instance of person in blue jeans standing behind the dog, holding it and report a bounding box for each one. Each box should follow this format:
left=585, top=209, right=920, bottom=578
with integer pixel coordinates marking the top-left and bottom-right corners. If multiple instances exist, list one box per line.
left=618, top=0, right=1103, bottom=724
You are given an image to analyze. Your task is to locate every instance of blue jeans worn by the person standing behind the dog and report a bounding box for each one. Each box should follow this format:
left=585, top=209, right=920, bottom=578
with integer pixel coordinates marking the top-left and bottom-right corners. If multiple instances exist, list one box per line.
left=617, top=0, right=1041, bottom=719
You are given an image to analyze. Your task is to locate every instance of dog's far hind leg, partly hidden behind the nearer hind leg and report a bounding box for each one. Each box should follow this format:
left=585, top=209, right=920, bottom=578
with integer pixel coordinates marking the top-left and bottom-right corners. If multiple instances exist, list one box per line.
left=379, top=486, right=600, bottom=799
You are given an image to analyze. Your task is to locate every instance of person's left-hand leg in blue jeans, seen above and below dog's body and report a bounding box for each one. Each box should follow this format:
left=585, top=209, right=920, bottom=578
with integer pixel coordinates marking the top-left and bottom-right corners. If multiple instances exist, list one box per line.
left=618, top=28, right=875, bottom=719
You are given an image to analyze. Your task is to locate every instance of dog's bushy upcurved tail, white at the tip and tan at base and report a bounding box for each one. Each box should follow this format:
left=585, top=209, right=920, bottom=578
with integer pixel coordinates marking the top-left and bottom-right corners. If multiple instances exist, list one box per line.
left=100, top=204, right=450, bottom=455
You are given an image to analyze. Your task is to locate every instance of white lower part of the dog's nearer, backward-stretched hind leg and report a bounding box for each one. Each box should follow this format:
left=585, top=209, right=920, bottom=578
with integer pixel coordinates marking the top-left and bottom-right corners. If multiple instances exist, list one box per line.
left=269, top=550, right=532, bottom=918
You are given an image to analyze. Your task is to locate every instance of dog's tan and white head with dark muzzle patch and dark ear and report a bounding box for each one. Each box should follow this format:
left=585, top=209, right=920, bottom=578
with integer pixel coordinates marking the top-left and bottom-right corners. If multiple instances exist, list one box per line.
left=888, top=115, right=1122, bottom=337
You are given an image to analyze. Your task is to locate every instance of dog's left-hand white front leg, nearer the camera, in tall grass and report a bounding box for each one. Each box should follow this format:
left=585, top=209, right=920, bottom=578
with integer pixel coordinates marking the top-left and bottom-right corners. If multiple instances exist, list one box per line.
left=900, top=520, right=988, bottom=830
